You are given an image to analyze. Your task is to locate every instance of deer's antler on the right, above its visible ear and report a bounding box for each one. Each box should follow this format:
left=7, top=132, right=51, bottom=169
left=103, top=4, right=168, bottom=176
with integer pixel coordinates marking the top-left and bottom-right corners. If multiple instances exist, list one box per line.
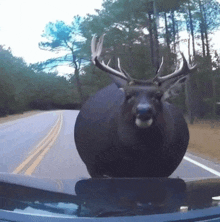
left=153, top=53, right=197, bottom=83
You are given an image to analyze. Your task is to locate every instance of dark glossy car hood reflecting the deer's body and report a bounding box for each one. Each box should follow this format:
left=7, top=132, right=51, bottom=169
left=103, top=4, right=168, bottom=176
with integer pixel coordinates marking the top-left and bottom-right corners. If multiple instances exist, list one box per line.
left=0, top=173, right=220, bottom=217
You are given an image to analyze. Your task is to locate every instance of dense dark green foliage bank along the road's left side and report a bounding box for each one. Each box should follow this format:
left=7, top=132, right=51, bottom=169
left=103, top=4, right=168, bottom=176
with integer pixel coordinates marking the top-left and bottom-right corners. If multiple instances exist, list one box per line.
left=0, top=46, right=78, bottom=116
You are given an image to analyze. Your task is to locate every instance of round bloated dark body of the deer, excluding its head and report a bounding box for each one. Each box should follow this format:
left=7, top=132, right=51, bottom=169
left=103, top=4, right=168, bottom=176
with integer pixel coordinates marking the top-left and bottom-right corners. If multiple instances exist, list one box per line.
left=75, top=84, right=189, bottom=177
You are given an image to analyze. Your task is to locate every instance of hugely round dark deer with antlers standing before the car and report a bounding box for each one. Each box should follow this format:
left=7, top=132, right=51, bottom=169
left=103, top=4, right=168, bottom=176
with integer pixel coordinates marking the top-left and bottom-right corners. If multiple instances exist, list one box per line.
left=74, top=35, right=196, bottom=178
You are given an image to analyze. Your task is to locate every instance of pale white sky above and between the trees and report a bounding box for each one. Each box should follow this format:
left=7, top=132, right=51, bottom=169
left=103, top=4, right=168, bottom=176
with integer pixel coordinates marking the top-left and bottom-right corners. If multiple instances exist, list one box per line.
left=0, top=0, right=220, bottom=73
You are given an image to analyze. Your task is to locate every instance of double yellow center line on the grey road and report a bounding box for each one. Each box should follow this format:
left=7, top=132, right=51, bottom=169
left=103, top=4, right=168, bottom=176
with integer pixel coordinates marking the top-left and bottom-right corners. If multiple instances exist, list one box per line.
left=13, top=113, right=63, bottom=175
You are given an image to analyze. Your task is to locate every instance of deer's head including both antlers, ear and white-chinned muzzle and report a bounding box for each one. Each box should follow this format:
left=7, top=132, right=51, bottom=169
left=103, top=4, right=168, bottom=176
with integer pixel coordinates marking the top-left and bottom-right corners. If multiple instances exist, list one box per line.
left=91, top=35, right=196, bottom=128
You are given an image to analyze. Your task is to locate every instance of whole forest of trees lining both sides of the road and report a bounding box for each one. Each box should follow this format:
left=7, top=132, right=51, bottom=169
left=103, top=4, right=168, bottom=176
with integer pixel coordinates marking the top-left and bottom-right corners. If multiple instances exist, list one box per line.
left=0, top=0, right=220, bottom=123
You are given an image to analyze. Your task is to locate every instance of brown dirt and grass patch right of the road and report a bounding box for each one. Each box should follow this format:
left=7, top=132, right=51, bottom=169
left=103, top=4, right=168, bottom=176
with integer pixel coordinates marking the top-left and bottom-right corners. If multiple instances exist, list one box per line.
left=188, top=121, right=220, bottom=163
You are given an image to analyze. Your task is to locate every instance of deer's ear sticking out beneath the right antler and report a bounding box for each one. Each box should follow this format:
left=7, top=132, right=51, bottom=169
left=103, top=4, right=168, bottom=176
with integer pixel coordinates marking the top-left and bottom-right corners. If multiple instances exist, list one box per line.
left=162, top=76, right=188, bottom=100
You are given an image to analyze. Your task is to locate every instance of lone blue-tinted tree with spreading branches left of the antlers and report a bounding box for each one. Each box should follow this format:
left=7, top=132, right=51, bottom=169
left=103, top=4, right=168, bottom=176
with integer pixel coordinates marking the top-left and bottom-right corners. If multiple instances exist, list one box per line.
left=35, top=16, right=86, bottom=102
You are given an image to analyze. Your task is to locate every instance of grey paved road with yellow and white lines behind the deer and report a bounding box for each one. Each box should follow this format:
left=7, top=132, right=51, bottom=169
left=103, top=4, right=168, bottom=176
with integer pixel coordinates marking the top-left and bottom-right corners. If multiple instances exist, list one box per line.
left=0, top=110, right=220, bottom=180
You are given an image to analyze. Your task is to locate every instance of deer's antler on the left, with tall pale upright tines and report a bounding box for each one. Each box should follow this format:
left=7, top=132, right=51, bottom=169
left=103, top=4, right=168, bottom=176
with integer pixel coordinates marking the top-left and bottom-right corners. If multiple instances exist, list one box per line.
left=91, top=34, right=132, bottom=82
